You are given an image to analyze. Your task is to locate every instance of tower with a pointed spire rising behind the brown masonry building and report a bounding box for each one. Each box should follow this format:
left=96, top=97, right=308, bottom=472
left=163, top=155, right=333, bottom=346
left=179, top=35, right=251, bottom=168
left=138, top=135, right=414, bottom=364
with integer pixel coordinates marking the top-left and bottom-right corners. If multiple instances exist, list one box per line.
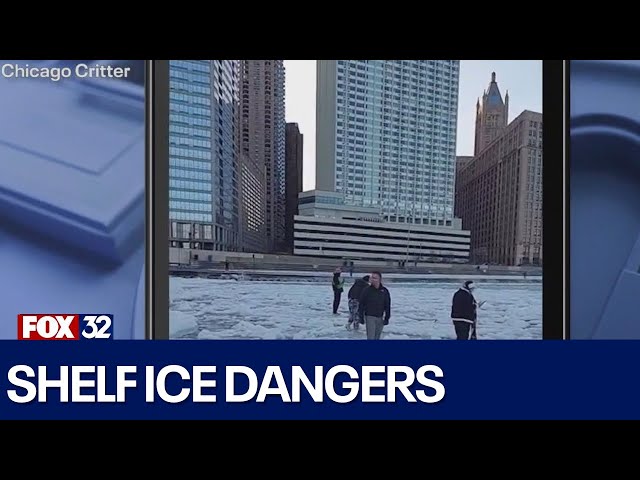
left=473, top=72, right=509, bottom=155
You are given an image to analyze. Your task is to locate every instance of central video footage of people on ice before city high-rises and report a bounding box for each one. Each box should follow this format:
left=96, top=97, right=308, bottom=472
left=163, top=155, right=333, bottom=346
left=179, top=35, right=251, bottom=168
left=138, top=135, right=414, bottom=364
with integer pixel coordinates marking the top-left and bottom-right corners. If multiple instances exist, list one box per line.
left=168, top=60, right=543, bottom=340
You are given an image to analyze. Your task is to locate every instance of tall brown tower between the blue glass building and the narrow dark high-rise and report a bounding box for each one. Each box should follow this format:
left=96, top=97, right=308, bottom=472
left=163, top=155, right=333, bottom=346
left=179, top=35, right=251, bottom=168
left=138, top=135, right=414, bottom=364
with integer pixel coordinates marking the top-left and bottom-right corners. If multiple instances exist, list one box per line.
left=239, top=60, right=286, bottom=252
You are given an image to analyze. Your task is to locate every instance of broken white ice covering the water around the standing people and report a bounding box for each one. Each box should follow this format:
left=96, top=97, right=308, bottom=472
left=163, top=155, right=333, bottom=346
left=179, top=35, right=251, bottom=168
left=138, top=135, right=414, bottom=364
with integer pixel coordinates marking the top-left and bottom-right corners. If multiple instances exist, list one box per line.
left=170, top=277, right=542, bottom=340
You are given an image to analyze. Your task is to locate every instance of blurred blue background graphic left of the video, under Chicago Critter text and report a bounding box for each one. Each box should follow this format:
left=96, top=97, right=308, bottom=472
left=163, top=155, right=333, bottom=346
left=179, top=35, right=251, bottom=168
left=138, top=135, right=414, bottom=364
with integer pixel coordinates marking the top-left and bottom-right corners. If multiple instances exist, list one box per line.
left=0, top=60, right=146, bottom=339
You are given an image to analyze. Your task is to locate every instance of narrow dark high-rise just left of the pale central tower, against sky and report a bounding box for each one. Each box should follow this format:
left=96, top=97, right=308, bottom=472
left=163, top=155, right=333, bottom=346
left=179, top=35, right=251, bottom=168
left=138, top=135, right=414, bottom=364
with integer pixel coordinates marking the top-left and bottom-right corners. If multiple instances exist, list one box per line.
left=285, top=123, right=303, bottom=252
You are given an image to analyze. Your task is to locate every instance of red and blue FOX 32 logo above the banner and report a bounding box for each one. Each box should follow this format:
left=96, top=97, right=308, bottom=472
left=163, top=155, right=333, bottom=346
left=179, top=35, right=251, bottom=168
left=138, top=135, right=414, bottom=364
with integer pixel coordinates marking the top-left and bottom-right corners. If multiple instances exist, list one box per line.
left=18, top=313, right=113, bottom=340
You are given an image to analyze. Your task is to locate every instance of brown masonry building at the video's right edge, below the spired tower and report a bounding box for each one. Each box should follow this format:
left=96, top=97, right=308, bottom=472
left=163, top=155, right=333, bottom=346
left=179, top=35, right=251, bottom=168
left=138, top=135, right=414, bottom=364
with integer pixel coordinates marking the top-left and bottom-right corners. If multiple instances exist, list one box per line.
left=456, top=110, right=543, bottom=265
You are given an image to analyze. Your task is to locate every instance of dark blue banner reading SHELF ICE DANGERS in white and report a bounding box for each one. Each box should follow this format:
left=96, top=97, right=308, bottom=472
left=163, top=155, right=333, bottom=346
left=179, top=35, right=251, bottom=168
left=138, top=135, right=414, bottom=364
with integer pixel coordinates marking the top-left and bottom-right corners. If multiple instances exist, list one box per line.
left=0, top=341, right=640, bottom=420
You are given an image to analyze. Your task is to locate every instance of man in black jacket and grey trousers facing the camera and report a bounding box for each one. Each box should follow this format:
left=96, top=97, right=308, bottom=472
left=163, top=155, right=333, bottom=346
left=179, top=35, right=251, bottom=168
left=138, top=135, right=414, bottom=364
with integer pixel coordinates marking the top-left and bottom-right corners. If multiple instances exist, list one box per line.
left=358, top=272, right=391, bottom=340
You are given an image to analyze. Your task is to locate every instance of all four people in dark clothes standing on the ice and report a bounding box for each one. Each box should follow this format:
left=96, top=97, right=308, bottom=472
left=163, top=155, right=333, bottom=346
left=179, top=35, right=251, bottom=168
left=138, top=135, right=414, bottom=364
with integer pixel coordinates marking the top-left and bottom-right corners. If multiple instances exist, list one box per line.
left=331, top=268, right=484, bottom=340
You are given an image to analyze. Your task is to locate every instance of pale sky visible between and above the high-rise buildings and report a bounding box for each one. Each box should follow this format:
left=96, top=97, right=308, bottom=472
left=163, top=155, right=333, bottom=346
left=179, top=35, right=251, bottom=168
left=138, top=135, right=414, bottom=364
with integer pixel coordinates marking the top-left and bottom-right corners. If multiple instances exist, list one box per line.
left=284, top=60, right=542, bottom=190
